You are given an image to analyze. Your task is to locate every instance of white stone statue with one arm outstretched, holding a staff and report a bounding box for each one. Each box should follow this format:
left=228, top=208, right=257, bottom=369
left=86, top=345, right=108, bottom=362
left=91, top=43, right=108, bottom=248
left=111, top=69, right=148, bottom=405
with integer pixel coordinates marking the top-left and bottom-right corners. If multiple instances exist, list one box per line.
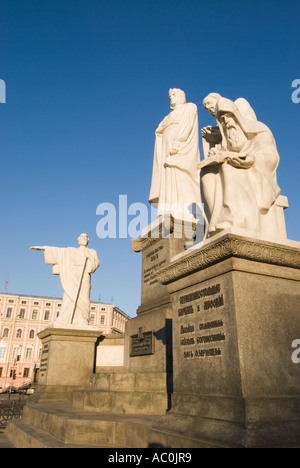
left=30, top=234, right=99, bottom=328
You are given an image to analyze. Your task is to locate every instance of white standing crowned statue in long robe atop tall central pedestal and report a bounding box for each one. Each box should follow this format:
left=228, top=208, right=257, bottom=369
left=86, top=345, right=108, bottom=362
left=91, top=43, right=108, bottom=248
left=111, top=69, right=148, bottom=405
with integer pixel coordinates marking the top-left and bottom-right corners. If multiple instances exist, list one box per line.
left=149, top=88, right=200, bottom=219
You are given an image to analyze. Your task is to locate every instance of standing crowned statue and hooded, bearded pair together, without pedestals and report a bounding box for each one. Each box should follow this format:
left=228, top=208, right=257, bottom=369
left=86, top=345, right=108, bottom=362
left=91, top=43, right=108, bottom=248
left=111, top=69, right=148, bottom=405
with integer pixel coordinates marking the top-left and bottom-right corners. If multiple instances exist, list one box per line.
left=149, top=89, right=280, bottom=237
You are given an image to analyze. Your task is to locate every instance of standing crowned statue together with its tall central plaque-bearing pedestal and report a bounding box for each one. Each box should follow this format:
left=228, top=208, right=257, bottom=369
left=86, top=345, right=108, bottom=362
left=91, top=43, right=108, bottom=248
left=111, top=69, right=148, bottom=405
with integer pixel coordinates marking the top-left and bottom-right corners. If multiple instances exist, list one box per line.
left=125, top=88, right=200, bottom=392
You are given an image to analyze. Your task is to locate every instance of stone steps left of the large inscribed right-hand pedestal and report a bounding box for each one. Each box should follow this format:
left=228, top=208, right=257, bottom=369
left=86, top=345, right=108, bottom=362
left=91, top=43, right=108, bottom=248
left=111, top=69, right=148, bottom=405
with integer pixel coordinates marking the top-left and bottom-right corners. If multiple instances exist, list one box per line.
left=6, top=371, right=173, bottom=448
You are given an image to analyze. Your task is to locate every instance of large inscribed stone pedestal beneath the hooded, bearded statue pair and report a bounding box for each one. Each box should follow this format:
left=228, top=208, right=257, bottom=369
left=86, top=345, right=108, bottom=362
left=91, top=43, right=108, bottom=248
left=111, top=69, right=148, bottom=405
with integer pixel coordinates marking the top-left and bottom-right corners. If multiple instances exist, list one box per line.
left=157, top=234, right=300, bottom=447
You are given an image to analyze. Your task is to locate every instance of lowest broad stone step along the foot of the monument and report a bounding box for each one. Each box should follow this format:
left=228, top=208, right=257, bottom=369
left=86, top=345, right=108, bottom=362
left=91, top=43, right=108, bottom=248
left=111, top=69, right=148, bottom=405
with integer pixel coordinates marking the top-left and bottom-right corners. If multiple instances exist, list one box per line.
left=6, top=402, right=233, bottom=448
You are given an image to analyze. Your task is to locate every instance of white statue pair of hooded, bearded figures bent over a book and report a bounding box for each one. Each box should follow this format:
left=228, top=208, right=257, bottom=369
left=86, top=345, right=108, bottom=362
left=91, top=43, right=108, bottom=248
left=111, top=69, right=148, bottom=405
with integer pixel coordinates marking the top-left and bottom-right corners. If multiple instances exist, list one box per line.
left=199, top=94, right=280, bottom=237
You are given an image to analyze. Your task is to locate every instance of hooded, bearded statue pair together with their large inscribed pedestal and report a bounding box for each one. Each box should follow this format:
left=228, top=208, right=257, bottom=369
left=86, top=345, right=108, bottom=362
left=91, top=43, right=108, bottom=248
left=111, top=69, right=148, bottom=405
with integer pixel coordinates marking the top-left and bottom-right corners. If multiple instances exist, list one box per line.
left=150, top=93, right=300, bottom=447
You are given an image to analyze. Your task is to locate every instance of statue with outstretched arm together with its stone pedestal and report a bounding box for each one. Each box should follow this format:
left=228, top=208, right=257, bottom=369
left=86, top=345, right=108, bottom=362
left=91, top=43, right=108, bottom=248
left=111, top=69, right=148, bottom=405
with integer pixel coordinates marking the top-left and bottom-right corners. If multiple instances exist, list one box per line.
left=31, top=234, right=102, bottom=401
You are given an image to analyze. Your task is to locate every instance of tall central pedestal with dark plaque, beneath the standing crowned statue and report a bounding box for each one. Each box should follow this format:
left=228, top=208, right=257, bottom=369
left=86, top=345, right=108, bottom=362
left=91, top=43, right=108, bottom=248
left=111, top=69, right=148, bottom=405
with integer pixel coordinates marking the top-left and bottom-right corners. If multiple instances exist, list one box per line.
left=124, top=215, right=193, bottom=373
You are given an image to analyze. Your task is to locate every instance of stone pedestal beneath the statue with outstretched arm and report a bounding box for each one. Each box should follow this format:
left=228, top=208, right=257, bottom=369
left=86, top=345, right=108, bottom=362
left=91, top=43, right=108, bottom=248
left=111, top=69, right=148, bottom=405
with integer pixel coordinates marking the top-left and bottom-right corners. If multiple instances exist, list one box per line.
left=34, top=327, right=102, bottom=401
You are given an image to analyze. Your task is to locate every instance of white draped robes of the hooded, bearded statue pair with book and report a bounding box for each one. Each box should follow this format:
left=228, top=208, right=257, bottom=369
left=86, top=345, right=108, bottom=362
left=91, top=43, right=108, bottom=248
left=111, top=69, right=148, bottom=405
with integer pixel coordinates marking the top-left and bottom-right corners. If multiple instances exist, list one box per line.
left=201, top=98, right=280, bottom=235
